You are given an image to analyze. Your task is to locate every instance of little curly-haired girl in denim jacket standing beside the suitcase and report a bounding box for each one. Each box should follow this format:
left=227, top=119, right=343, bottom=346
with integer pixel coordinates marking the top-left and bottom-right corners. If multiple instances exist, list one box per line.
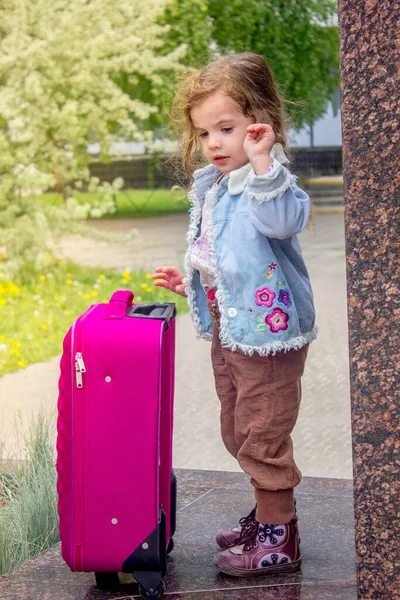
left=152, top=52, right=317, bottom=577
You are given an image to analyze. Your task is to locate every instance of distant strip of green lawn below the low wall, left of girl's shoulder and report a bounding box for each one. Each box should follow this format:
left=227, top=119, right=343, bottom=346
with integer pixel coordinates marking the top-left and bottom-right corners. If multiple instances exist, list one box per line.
left=39, top=189, right=189, bottom=218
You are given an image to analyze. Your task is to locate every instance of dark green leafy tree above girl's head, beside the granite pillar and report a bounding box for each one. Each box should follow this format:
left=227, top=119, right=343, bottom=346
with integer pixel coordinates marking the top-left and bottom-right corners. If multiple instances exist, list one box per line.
left=208, top=0, right=339, bottom=128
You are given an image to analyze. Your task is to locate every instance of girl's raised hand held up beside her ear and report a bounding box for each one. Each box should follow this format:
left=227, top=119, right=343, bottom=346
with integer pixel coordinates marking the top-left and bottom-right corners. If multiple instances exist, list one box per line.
left=243, top=123, right=276, bottom=175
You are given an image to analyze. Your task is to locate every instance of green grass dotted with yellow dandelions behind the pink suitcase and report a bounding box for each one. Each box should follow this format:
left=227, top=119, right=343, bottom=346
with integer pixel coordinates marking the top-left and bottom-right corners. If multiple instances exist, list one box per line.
left=0, top=257, right=187, bottom=376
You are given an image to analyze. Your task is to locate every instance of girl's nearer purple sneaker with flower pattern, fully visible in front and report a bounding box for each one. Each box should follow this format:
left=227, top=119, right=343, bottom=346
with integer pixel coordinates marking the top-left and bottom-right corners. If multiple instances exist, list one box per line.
left=214, top=515, right=301, bottom=577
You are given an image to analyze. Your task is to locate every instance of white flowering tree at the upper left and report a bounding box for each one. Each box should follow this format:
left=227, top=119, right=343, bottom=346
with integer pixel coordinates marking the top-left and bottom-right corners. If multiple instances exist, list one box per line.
left=0, top=0, right=182, bottom=279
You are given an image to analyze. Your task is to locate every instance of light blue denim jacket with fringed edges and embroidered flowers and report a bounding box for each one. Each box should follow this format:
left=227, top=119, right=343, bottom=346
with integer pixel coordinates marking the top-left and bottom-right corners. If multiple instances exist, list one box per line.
left=184, top=152, right=317, bottom=356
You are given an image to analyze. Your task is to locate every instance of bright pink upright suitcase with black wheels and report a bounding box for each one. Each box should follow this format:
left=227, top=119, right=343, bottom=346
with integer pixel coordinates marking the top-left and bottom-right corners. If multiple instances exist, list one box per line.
left=57, top=291, right=176, bottom=600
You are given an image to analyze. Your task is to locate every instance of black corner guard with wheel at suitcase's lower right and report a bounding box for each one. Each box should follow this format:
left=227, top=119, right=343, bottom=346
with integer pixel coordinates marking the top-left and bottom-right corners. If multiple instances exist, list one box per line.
left=122, top=509, right=166, bottom=600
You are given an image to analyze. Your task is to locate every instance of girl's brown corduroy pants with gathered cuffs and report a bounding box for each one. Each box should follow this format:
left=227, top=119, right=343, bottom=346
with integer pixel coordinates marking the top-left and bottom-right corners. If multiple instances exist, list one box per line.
left=211, top=321, right=308, bottom=524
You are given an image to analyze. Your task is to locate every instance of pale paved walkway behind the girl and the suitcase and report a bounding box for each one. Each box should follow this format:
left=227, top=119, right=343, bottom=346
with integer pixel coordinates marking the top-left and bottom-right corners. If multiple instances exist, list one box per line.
left=0, top=214, right=352, bottom=478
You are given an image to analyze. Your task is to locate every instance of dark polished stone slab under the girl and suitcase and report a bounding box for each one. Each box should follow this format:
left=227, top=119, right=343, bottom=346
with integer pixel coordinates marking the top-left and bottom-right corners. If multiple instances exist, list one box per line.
left=0, top=470, right=356, bottom=600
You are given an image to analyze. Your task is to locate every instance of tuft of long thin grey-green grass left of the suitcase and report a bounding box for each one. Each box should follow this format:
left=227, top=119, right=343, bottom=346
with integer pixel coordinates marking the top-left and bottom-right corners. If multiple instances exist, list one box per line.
left=0, top=412, right=59, bottom=575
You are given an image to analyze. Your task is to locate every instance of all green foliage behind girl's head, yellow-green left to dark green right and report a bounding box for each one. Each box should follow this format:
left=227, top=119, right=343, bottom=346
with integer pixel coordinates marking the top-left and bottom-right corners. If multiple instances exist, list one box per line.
left=144, top=0, right=339, bottom=128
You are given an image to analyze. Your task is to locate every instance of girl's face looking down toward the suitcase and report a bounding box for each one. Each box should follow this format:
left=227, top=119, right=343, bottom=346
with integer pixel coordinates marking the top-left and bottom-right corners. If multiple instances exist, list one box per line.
left=190, top=92, right=253, bottom=174
